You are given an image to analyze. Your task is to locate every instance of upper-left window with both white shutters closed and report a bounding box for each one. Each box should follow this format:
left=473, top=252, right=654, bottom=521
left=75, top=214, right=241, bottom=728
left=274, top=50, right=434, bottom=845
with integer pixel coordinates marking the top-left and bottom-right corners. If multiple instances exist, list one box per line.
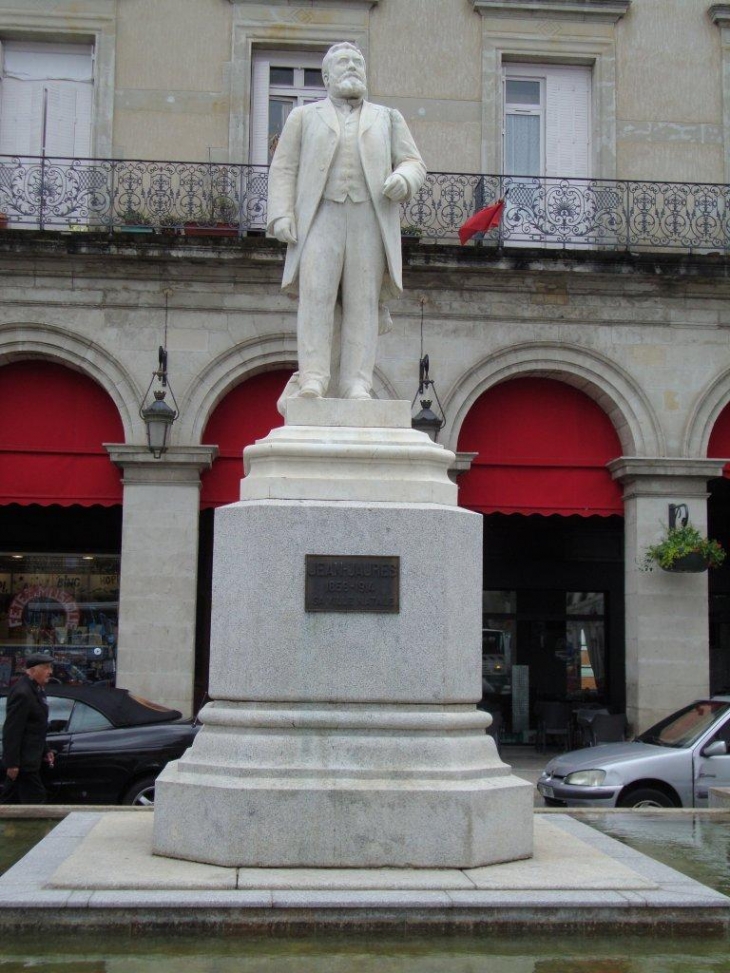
left=0, top=41, right=94, bottom=158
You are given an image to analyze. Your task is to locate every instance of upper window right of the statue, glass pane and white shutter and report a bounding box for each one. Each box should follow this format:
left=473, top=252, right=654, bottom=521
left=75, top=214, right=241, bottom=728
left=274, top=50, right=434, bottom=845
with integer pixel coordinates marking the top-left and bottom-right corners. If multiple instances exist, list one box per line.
left=504, top=64, right=591, bottom=179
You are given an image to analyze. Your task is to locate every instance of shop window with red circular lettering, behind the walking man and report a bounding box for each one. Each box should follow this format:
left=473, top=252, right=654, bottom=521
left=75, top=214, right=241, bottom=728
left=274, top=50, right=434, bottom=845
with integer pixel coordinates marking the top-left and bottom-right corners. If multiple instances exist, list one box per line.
left=0, top=552, right=120, bottom=687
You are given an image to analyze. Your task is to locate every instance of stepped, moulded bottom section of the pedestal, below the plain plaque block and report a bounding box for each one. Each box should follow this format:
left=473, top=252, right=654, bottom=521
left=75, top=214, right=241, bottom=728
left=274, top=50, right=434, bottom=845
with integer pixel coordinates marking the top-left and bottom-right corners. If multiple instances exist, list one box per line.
left=154, top=703, right=532, bottom=868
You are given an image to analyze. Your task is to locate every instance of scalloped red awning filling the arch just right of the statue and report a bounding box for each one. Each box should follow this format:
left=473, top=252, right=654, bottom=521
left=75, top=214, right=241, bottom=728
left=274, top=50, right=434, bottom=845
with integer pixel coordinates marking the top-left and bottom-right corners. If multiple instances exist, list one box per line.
left=458, top=378, right=623, bottom=517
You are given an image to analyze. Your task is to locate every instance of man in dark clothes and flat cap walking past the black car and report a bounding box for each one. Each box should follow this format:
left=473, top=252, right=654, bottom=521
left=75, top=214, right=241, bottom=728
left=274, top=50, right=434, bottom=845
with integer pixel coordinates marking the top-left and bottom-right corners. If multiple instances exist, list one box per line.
left=0, top=653, right=53, bottom=804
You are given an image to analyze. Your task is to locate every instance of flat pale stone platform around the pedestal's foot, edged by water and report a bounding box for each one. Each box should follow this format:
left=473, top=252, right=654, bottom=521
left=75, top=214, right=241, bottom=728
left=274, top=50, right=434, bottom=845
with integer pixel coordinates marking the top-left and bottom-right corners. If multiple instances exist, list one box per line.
left=0, top=811, right=730, bottom=935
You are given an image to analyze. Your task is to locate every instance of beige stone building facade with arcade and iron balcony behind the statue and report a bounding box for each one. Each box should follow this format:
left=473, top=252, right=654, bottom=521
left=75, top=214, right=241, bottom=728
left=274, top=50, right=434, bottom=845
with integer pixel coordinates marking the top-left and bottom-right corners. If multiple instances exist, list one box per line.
left=0, top=0, right=730, bottom=741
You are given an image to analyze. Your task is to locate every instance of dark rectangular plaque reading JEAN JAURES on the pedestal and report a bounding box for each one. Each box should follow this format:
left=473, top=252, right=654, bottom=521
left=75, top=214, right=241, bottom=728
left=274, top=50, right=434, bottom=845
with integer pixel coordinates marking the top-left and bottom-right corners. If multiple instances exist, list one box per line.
left=304, top=554, right=400, bottom=612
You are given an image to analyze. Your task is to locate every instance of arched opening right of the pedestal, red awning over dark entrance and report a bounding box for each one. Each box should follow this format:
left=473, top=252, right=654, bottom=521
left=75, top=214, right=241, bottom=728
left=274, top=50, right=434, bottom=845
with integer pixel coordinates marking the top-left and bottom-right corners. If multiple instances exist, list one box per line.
left=458, top=377, right=625, bottom=743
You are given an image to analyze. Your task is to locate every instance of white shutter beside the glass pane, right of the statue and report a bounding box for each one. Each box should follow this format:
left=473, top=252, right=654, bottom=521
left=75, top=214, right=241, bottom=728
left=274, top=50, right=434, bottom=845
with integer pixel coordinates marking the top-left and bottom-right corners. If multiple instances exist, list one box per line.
left=545, top=66, right=591, bottom=179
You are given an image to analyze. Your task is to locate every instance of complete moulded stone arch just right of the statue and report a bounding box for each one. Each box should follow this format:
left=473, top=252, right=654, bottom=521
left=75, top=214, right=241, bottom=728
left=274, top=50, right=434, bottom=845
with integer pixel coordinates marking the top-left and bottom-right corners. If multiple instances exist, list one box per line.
left=442, top=341, right=665, bottom=456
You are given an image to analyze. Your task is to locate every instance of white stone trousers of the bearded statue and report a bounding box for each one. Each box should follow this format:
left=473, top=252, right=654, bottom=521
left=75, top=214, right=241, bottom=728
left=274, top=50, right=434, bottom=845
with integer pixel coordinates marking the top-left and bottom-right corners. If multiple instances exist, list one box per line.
left=297, top=199, right=386, bottom=398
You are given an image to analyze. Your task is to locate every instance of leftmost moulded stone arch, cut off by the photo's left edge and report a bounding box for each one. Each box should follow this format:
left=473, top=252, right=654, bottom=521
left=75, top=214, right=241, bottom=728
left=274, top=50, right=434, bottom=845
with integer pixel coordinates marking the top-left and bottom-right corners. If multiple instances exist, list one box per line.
left=0, top=323, right=136, bottom=443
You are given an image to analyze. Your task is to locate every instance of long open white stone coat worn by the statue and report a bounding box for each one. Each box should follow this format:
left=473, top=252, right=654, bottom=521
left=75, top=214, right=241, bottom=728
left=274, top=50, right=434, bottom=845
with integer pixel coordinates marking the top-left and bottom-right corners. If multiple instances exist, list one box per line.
left=267, top=98, right=426, bottom=300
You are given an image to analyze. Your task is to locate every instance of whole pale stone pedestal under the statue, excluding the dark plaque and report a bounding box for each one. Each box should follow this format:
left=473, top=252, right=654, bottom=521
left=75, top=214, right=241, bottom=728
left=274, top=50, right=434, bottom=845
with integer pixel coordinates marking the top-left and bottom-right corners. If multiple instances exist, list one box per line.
left=154, top=400, right=532, bottom=868
